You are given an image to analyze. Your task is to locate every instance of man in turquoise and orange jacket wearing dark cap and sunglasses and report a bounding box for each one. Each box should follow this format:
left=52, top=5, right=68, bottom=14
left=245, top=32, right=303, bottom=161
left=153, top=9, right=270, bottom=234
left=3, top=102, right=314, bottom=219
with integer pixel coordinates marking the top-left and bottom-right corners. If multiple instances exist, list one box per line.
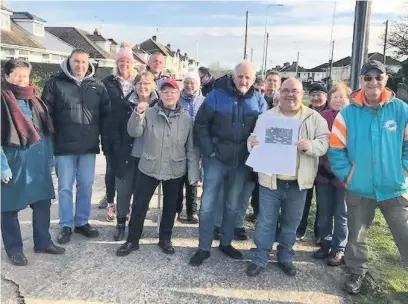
left=328, top=60, right=408, bottom=294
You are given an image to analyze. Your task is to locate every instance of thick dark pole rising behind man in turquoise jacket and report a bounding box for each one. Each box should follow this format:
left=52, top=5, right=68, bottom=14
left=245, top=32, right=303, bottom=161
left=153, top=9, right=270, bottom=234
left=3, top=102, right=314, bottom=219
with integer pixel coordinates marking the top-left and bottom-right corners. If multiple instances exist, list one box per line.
left=350, top=1, right=369, bottom=90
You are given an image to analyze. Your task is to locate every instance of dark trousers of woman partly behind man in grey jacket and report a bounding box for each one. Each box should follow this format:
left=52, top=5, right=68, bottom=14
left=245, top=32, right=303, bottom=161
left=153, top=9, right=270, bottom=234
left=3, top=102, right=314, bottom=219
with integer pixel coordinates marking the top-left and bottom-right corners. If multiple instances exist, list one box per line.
left=115, top=157, right=140, bottom=224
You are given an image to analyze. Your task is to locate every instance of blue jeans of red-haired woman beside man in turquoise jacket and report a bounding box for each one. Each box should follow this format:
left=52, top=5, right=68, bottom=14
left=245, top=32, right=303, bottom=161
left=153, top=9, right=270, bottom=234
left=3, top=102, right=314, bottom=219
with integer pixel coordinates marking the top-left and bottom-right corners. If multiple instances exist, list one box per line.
left=316, top=183, right=348, bottom=251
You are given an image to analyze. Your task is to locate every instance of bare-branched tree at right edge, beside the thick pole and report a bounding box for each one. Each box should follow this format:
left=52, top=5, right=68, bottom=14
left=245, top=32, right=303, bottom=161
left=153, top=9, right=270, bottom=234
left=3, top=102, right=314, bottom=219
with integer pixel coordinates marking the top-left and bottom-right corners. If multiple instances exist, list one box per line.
left=382, top=15, right=408, bottom=58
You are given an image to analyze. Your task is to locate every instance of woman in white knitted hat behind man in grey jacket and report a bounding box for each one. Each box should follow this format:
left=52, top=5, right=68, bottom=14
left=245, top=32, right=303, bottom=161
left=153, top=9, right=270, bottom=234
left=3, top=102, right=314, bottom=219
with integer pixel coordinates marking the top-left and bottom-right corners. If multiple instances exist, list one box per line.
left=177, top=72, right=204, bottom=224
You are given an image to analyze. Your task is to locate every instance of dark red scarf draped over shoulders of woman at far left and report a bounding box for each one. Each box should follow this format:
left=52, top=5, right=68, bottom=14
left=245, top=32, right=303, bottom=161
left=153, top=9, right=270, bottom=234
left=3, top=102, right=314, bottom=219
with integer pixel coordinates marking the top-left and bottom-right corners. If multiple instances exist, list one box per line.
left=1, top=82, right=54, bottom=148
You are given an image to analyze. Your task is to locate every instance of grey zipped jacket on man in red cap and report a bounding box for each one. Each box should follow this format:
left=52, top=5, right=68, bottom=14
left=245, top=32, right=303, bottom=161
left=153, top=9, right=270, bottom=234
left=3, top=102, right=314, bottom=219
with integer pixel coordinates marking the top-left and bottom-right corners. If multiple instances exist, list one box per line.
left=127, top=101, right=200, bottom=182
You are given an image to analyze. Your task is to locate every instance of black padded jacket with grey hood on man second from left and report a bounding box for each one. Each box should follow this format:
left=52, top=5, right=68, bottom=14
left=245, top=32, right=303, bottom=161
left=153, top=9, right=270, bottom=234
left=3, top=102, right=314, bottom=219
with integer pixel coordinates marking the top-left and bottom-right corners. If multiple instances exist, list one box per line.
left=42, top=59, right=110, bottom=155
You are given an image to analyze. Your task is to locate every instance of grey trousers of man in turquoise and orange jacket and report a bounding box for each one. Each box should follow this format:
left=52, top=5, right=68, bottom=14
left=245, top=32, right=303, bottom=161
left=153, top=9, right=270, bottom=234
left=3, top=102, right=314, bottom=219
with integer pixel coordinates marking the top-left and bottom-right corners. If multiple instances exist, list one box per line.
left=344, top=192, right=408, bottom=275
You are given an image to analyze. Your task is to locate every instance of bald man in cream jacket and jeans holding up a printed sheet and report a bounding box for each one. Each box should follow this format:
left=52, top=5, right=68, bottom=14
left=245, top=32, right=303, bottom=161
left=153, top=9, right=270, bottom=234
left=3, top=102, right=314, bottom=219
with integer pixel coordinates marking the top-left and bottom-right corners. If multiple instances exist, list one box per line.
left=247, top=78, right=330, bottom=276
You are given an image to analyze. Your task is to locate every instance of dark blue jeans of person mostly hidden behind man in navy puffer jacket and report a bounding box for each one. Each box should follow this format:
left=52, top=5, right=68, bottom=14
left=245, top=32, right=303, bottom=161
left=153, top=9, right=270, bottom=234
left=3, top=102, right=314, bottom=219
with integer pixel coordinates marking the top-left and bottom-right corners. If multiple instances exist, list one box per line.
left=215, top=177, right=255, bottom=228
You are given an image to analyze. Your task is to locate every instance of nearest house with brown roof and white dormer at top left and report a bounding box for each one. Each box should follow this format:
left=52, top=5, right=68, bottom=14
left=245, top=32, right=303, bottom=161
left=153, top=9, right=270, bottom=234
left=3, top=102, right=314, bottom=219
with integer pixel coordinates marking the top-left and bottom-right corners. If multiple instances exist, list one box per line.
left=0, top=6, right=73, bottom=63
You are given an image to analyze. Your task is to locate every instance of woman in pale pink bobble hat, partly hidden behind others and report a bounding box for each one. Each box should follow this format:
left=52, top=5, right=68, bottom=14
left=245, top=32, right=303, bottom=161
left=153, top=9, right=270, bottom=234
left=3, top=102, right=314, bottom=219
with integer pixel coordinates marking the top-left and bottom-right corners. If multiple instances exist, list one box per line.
left=99, top=42, right=136, bottom=221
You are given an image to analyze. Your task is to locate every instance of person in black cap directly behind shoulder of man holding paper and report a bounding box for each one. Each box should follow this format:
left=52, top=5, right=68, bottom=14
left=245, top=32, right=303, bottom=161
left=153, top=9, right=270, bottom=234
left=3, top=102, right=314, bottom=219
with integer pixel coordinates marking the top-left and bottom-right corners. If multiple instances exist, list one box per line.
left=296, top=82, right=330, bottom=243
